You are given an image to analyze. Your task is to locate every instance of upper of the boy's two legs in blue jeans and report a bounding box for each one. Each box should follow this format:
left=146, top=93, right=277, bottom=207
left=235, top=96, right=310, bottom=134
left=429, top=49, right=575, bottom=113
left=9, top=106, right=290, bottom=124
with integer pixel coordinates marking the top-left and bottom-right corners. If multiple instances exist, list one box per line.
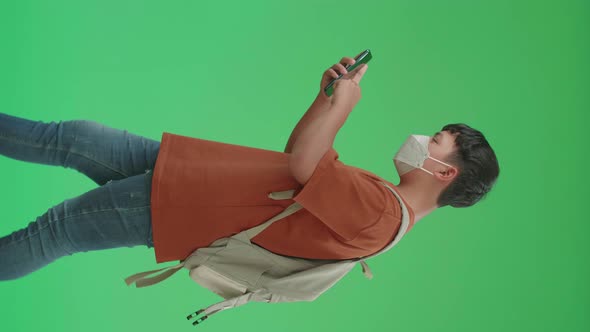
left=0, top=113, right=160, bottom=185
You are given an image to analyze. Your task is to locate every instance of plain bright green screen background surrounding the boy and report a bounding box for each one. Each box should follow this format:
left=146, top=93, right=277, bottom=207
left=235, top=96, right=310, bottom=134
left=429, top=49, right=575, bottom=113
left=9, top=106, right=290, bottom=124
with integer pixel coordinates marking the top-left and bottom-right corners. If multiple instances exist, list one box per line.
left=0, top=0, right=590, bottom=332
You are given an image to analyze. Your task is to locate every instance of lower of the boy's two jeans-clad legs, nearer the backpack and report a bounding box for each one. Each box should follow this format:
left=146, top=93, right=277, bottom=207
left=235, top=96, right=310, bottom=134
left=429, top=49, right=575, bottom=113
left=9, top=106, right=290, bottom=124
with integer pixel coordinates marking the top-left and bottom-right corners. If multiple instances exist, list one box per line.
left=0, top=171, right=153, bottom=280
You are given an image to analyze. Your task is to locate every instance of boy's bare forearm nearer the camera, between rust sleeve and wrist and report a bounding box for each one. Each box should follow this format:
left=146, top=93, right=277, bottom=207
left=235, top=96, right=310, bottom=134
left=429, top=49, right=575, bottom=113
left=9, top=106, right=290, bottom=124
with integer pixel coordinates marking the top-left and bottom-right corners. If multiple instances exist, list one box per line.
left=289, top=101, right=352, bottom=185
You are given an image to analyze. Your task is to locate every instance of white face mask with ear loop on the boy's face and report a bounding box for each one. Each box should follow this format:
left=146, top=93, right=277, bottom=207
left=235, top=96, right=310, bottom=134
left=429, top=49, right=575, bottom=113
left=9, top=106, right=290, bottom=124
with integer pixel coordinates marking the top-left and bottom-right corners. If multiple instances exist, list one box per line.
left=393, top=135, right=453, bottom=176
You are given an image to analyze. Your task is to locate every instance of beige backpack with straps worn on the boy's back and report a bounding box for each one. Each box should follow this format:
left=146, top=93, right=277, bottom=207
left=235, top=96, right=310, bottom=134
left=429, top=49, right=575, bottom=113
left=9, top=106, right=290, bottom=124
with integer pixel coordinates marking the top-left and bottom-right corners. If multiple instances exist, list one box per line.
left=125, top=182, right=409, bottom=325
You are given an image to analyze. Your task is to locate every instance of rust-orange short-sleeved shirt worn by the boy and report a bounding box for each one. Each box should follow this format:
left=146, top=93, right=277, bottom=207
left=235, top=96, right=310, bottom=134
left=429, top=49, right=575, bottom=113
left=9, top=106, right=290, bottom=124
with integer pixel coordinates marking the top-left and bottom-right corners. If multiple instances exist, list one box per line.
left=151, top=132, right=414, bottom=263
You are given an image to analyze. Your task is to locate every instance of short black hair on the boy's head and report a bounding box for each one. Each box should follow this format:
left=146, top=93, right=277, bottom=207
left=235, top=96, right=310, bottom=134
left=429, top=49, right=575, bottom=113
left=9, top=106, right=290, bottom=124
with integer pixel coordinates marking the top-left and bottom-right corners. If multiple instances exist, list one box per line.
left=437, top=123, right=500, bottom=207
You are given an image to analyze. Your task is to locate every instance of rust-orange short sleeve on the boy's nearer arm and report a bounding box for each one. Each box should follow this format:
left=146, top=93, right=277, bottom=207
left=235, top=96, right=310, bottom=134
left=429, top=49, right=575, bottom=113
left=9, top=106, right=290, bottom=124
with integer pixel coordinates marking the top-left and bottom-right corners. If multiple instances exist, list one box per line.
left=293, top=148, right=387, bottom=242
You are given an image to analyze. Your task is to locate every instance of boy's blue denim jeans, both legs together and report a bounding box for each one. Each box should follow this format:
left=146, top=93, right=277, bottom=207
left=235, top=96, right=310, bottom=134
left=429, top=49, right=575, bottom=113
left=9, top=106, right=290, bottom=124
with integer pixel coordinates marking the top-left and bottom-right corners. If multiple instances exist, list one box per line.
left=0, top=113, right=160, bottom=280
